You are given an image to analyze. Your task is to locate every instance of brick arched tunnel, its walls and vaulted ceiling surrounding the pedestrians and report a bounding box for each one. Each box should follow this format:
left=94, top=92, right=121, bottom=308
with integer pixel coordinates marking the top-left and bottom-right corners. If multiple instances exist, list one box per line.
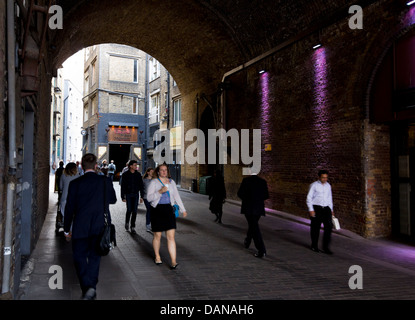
left=0, top=0, right=415, bottom=300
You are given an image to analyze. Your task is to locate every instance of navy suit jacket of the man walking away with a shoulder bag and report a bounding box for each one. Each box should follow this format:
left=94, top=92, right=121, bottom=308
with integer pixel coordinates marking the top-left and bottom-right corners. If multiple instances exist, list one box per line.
left=64, top=172, right=117, bottom=239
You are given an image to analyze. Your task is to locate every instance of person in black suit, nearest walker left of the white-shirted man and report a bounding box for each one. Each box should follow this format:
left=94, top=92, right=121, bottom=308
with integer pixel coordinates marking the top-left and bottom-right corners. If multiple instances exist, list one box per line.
left=238, top=170, right=269, bottom=258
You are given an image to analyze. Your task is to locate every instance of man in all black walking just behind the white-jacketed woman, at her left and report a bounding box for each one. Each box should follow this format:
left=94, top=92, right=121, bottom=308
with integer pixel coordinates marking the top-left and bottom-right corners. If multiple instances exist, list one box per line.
left=121, top=160, right=144, bottom=234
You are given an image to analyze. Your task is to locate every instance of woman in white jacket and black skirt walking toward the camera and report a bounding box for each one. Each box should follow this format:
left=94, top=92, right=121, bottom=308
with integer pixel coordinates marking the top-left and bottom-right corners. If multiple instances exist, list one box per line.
left=147, top=164, right=187, bottom=270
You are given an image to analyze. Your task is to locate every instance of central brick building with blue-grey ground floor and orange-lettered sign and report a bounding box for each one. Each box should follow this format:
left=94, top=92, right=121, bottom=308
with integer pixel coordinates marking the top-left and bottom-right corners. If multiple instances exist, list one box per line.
left=81, top=44, right=146, bottom=179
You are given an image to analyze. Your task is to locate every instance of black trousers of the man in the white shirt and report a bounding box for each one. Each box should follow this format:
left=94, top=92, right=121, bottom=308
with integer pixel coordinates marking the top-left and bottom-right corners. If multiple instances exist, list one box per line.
left=310, top=206, right=333, bottom=250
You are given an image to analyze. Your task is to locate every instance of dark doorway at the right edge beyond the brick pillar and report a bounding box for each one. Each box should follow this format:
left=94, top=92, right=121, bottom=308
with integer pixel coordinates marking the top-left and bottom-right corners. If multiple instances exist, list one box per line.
left=392, top=122, right=415, bottom=238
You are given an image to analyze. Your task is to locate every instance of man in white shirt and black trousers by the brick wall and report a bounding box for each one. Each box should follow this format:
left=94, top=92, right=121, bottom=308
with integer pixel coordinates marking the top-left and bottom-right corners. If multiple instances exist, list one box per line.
left=307, top=170, right=334, bottom=254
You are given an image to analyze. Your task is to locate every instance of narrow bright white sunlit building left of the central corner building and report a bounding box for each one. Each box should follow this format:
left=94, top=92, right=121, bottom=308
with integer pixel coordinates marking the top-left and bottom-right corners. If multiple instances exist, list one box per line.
left=63, top=79, right=83, bottom=164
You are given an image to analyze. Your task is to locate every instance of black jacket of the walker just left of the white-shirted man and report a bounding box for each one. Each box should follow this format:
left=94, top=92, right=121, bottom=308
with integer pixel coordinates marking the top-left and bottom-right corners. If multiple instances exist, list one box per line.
left=238, top=175, right=269, bottom=216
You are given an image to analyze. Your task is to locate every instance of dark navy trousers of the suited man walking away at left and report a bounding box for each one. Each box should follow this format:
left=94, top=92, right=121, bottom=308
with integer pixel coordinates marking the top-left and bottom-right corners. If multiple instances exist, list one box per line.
left=72, top=236, right=101, bottom=294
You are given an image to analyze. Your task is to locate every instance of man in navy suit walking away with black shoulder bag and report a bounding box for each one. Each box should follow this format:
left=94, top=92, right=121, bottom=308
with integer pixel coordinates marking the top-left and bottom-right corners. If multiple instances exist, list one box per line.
left=64, top=153, right=117, bottom=300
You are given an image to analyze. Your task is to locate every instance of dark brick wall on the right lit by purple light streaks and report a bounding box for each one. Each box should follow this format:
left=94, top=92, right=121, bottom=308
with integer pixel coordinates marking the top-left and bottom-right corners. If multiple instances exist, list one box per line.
left=218, top=2, right=412, bottom=237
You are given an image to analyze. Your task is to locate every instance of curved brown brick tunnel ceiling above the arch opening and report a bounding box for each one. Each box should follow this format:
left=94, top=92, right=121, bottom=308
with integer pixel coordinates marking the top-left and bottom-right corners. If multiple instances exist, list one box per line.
left=49, top=0, right=353, bottom=93
